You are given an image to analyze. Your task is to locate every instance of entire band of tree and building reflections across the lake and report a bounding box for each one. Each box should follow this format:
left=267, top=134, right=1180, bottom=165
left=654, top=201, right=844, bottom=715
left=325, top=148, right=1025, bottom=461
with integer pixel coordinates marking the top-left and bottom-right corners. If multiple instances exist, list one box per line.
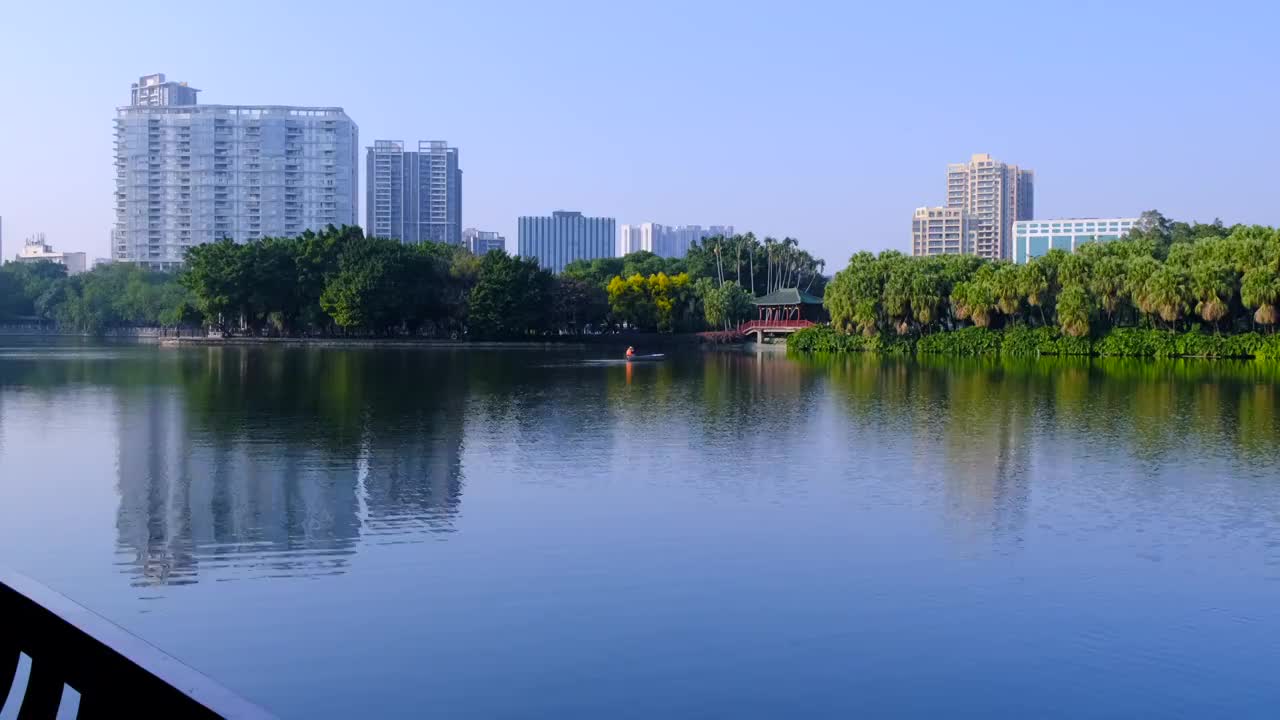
left=49, top=347, right=1280, bottom=584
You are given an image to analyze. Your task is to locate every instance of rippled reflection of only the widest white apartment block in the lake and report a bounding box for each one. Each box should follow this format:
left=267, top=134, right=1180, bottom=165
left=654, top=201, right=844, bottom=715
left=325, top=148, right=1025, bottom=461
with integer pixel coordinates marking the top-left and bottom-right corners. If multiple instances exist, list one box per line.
left=116, top=388, right=360, bottom=584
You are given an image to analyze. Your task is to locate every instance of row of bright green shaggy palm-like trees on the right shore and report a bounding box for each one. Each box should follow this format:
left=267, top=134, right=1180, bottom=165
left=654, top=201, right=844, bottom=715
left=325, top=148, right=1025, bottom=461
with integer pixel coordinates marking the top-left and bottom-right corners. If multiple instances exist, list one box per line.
left=824, top=211, right=1280, bottom=337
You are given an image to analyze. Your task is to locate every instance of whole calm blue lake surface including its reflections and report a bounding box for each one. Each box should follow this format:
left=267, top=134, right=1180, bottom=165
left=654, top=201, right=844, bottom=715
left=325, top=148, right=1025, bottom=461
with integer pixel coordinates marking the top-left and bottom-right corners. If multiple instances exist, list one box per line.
left=0, top=340, right=1280, bottom=719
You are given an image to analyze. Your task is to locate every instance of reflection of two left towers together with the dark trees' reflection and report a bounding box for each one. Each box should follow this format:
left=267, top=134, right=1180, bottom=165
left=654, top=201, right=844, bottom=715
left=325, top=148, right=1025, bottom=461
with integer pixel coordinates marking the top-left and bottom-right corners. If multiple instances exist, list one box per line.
left=118, top=347, right=466, bottom=584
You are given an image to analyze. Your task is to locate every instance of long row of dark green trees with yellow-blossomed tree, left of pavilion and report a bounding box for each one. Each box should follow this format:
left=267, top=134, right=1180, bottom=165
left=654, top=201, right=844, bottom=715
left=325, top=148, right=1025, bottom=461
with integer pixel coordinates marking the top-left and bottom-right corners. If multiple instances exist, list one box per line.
left=0, top=227, right=824, bottom=338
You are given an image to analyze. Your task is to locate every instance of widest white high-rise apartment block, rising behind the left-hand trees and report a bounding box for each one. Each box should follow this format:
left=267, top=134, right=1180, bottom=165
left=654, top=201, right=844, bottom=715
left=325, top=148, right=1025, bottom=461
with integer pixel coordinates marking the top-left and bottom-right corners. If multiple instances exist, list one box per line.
left=111, top=74, right=360, bottom=269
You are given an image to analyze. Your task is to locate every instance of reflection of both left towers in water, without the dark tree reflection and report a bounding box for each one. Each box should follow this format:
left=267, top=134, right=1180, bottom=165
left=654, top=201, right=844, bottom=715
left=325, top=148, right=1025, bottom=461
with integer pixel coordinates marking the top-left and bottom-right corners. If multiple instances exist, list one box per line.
left=116, top=378, right=465, bottom=584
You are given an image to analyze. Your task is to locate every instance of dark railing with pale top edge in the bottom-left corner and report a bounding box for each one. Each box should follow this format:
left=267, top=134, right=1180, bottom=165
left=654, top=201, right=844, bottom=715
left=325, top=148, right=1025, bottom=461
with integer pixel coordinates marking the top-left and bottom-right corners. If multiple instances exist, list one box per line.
left=0, top=574, right=271, bottom=720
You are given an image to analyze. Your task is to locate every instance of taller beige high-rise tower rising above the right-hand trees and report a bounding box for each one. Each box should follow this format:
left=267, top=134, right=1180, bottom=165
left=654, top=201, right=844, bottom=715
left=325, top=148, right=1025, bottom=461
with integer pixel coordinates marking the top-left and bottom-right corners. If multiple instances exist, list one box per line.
left=947, top=152, right=1036, bottom=259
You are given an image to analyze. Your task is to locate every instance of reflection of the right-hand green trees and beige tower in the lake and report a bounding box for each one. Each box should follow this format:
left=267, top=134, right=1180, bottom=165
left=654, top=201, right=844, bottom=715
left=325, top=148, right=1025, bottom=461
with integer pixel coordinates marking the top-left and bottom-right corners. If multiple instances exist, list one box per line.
left=814, top=355, right=1280, bottom=533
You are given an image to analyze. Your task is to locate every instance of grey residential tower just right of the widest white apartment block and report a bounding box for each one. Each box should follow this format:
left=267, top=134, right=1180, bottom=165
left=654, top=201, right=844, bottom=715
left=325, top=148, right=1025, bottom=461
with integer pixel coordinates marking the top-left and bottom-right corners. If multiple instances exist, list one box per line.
left=365, top=140, right=462, bottom=245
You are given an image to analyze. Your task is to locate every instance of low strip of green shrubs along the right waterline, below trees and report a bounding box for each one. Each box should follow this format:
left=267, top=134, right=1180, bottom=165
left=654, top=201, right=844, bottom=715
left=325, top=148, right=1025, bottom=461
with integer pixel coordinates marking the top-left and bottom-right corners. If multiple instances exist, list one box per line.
left=787, top=327, right=1280, bottom=359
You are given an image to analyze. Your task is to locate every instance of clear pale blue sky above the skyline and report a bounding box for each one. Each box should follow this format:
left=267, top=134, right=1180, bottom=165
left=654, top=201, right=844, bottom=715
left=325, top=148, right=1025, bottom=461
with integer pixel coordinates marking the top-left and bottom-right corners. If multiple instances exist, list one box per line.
left=0, top=0, right=1280, bottom=268
